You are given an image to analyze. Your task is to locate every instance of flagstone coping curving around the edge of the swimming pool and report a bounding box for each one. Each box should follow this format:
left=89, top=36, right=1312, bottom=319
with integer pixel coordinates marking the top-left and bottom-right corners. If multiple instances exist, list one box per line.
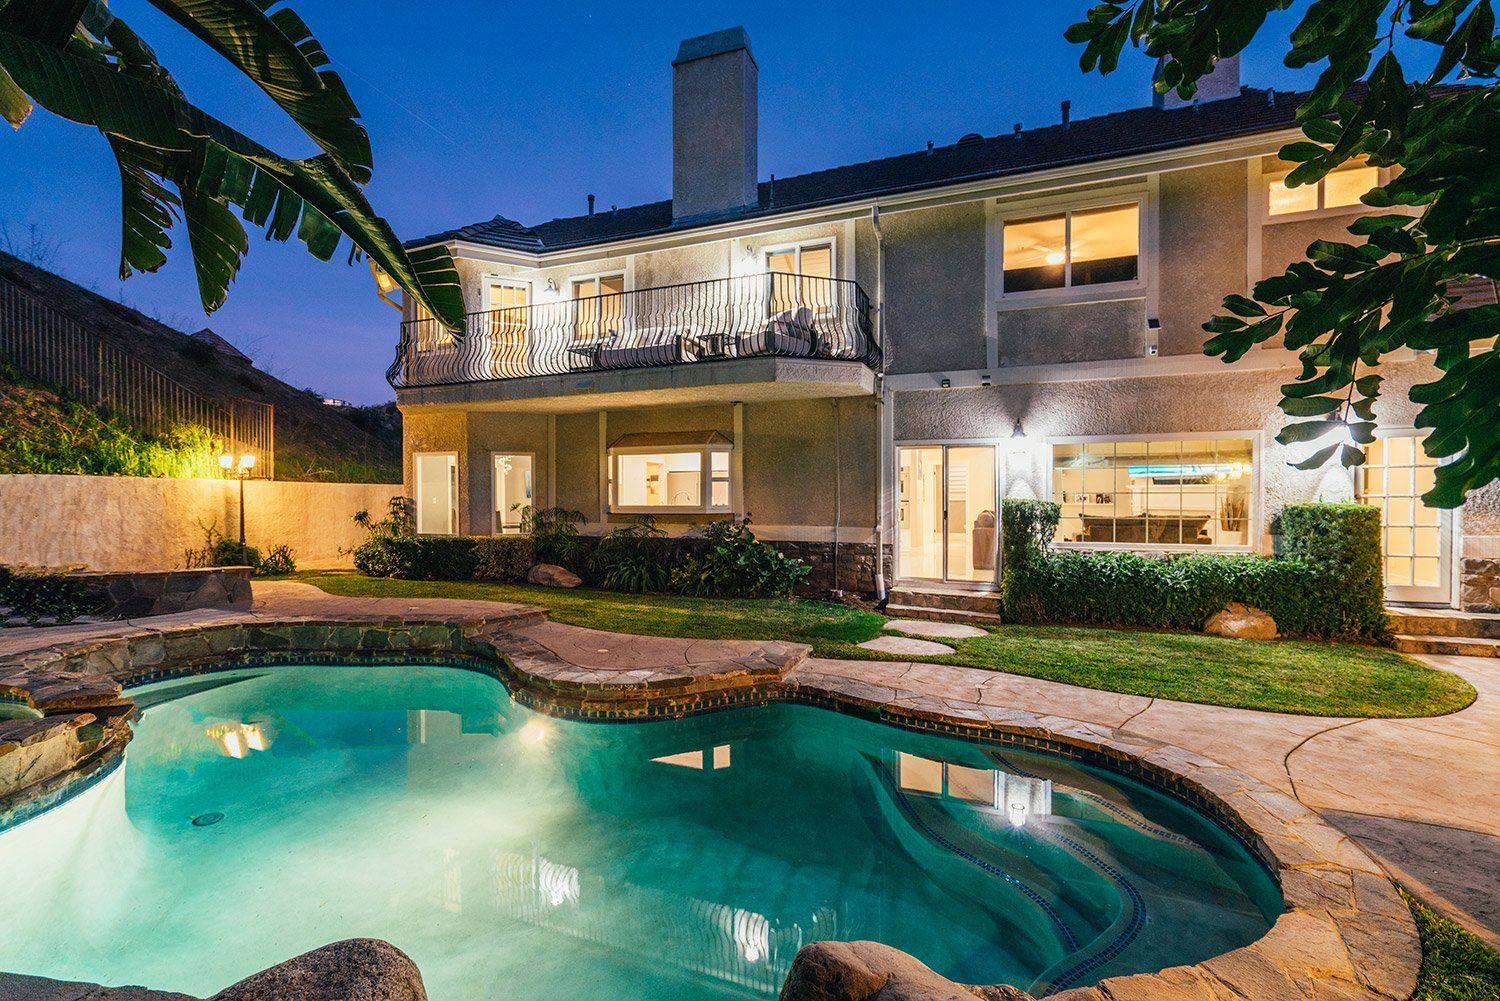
left=0, top=605, right=1422, bottom=1001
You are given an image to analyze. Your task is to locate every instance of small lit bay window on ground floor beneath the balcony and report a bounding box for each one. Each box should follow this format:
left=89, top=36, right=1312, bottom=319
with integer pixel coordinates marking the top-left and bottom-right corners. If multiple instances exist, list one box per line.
left=609, top=431, right=732, bottom=513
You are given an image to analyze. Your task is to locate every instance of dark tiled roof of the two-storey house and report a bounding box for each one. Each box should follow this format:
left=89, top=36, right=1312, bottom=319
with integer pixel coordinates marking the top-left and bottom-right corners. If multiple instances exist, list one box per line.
left=408, top=87, right=1305, bottom=252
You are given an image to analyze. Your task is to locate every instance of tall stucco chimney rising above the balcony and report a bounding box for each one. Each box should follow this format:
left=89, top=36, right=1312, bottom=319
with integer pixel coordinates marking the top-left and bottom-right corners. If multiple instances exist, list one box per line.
left=672, top=27, right=759, bottom=221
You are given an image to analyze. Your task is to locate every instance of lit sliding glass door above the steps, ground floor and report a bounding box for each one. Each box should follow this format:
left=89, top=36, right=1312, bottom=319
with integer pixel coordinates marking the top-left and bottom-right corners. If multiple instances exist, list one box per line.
left=897, top=444, right=999, bottom=585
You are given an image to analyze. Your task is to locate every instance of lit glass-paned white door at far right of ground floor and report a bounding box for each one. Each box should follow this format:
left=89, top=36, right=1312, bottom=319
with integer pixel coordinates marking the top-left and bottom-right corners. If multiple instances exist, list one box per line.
left=1359, top=431, right=1454, bottom=605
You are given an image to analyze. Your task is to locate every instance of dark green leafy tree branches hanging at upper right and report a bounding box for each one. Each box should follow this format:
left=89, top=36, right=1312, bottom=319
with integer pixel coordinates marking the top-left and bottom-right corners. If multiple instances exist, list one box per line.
left=1067, top=0, right=1500, bottom=507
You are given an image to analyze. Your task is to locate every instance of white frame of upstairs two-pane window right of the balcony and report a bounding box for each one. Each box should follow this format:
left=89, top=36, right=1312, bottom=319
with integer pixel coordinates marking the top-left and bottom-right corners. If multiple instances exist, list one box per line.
left=990, top=188, right=1155, bottom=309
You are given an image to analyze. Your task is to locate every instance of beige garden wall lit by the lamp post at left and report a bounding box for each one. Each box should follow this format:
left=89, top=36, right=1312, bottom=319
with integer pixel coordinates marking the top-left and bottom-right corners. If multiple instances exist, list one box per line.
left=0, top=476, right=405, bottom=570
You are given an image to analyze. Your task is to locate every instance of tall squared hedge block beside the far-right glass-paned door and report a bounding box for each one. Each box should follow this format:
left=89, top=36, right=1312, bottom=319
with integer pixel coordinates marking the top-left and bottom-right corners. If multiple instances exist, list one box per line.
left=1277, top=504, right=1391, bottom=639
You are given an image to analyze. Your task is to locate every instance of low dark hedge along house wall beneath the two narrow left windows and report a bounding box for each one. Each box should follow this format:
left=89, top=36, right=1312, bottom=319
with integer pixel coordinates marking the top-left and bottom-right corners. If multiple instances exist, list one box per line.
left=354, top=536, right=536, bottom=581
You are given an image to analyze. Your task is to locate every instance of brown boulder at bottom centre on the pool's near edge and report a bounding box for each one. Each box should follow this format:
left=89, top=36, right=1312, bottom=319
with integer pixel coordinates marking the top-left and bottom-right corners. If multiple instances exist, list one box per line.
left=782, top=942, right=1032, bottom=1001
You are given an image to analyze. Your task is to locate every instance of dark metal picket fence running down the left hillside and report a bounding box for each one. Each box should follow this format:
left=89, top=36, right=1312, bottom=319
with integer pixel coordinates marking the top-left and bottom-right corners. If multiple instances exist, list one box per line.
left=0, top=279, right=276, bottom=477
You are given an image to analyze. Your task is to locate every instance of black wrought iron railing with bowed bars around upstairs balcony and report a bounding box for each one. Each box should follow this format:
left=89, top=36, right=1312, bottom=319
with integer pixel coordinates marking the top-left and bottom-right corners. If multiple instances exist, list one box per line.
left=386, top=273, right=881, bottom=387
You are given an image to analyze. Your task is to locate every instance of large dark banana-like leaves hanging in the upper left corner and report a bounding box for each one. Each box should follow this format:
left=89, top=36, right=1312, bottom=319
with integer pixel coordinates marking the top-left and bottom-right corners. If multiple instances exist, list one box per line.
left=0, top=0, right=464, bottom=332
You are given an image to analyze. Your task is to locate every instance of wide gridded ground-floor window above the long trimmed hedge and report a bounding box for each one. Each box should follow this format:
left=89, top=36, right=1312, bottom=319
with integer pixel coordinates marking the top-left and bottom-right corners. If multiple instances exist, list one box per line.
left=1052, top=435, right=1257, bottom=549
